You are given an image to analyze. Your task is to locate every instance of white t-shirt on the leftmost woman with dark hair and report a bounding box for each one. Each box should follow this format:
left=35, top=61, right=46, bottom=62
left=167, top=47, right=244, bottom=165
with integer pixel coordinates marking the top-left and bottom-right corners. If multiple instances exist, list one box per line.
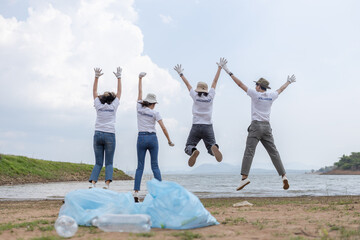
left=94, top=97, right=120, bottom=133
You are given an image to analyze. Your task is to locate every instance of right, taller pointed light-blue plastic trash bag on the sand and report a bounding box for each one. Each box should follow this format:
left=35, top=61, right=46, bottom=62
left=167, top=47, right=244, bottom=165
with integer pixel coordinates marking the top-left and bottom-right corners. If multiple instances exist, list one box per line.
left=140, top=179, right=219, bottom=229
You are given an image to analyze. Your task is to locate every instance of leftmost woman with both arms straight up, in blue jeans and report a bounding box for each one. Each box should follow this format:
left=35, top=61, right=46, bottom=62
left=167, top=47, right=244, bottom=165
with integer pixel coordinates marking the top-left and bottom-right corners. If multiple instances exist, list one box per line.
left=89, top=67, right=122, bottom=189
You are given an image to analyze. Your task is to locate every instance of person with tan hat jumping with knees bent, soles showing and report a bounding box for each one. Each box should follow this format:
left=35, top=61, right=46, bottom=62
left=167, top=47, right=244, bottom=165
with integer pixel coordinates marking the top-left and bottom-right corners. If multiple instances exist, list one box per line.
left=174, top=59, right=223, bottom=167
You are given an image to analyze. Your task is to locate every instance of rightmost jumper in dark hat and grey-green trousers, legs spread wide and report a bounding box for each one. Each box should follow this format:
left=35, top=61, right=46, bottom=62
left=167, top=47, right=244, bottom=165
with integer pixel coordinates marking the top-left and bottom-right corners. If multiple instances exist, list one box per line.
left=221, top=60, right=296, bottom=191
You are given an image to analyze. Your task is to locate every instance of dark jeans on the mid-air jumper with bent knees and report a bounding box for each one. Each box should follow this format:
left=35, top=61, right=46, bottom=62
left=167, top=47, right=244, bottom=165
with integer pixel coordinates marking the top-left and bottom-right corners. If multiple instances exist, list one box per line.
left=185, top=124, right=219, bottom=156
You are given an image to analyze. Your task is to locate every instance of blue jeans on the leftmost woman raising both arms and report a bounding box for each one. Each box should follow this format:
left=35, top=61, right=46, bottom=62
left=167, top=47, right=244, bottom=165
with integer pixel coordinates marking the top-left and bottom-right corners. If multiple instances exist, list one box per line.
left=89, top=131, right=116, bottom=182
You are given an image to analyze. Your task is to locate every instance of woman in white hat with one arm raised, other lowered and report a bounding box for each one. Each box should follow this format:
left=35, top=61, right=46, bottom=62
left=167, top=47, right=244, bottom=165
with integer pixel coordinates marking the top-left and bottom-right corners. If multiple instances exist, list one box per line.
left=134, top=72, right=174, bottom=202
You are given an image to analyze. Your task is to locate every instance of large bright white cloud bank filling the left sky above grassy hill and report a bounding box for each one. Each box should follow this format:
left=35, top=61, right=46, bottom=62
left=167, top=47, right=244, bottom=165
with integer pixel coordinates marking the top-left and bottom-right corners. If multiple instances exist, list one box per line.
left=0, top=0, right=180, bottom=167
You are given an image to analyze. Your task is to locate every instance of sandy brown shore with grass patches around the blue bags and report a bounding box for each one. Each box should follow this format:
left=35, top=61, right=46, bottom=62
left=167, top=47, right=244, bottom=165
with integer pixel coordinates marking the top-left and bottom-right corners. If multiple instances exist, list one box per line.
left=0, top=196, right=360, bottom=240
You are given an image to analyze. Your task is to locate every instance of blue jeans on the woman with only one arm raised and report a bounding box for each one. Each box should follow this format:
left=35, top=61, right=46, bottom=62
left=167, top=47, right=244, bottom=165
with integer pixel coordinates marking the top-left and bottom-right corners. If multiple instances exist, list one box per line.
left=134, top=132, right=161, bottom=191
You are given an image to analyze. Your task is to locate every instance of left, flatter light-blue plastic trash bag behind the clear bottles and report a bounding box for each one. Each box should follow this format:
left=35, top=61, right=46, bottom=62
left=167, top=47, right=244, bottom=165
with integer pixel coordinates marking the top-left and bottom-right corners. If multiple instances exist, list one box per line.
left=59, top=188, right=137, bottom=226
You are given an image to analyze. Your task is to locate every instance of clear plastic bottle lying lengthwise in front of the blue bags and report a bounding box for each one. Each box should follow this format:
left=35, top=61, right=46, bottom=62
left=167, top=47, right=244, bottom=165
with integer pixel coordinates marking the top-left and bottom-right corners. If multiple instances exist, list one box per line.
left=91, top=214, right=151, bottom=233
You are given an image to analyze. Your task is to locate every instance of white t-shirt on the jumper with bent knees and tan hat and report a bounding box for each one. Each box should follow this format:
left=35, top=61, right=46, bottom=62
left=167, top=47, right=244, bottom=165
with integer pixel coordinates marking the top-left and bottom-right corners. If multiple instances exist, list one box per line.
left=190, top=88, right=215, bottom=124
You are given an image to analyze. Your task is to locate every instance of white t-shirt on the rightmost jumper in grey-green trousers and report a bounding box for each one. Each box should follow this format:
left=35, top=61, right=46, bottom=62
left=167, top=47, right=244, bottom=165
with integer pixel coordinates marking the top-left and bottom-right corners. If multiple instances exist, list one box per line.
left=247, top=88, right=279, bottom=122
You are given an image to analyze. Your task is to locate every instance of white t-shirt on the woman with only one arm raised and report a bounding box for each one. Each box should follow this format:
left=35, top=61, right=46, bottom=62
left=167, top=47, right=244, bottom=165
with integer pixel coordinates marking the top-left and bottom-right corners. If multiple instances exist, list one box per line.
left=137, top=101, right=161, bottom=133
